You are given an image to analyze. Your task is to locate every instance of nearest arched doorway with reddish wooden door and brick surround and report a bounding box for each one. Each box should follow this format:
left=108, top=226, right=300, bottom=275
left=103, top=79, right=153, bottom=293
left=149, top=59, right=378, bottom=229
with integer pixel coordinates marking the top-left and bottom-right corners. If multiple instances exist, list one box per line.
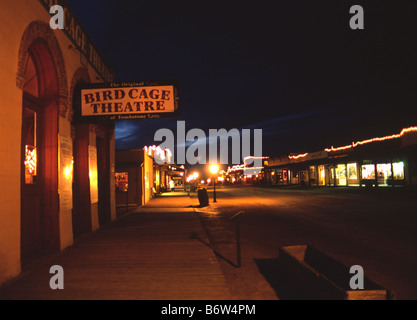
left=17, top=22, right=67, bottom=267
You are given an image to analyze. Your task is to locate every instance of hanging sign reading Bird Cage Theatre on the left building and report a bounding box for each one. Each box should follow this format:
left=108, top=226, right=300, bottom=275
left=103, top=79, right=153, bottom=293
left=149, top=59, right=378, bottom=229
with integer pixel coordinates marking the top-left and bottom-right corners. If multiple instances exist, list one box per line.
left=80, top=82, right=179, bottom=120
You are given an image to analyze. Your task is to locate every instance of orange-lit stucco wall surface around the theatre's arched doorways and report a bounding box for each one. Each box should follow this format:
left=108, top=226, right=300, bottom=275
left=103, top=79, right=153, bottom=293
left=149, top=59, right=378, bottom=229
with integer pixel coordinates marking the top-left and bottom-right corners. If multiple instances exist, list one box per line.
left=0, top=0, right=116, bottom=285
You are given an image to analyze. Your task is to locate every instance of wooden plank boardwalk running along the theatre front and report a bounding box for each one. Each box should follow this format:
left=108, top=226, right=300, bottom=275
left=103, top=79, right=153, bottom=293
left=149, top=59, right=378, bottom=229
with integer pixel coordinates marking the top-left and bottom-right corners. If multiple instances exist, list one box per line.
left=0, top=196, right=232, bottom=300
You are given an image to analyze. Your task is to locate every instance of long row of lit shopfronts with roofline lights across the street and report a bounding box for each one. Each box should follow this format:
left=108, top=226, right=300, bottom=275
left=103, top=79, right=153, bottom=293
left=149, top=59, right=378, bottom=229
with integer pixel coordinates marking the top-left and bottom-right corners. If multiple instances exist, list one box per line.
left=266, top=127, right=417, bottom=187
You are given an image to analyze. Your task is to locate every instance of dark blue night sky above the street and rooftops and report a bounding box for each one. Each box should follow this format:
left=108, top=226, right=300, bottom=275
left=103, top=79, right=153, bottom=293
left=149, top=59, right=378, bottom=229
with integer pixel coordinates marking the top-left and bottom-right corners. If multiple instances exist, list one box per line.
left=68, top=0, right=417, bottom=162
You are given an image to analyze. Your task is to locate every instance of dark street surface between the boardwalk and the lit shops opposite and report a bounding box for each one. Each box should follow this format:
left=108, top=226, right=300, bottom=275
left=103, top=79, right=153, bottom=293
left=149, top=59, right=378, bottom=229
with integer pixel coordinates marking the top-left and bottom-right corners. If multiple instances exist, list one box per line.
left=193, top=186, right=417, bottom=299
